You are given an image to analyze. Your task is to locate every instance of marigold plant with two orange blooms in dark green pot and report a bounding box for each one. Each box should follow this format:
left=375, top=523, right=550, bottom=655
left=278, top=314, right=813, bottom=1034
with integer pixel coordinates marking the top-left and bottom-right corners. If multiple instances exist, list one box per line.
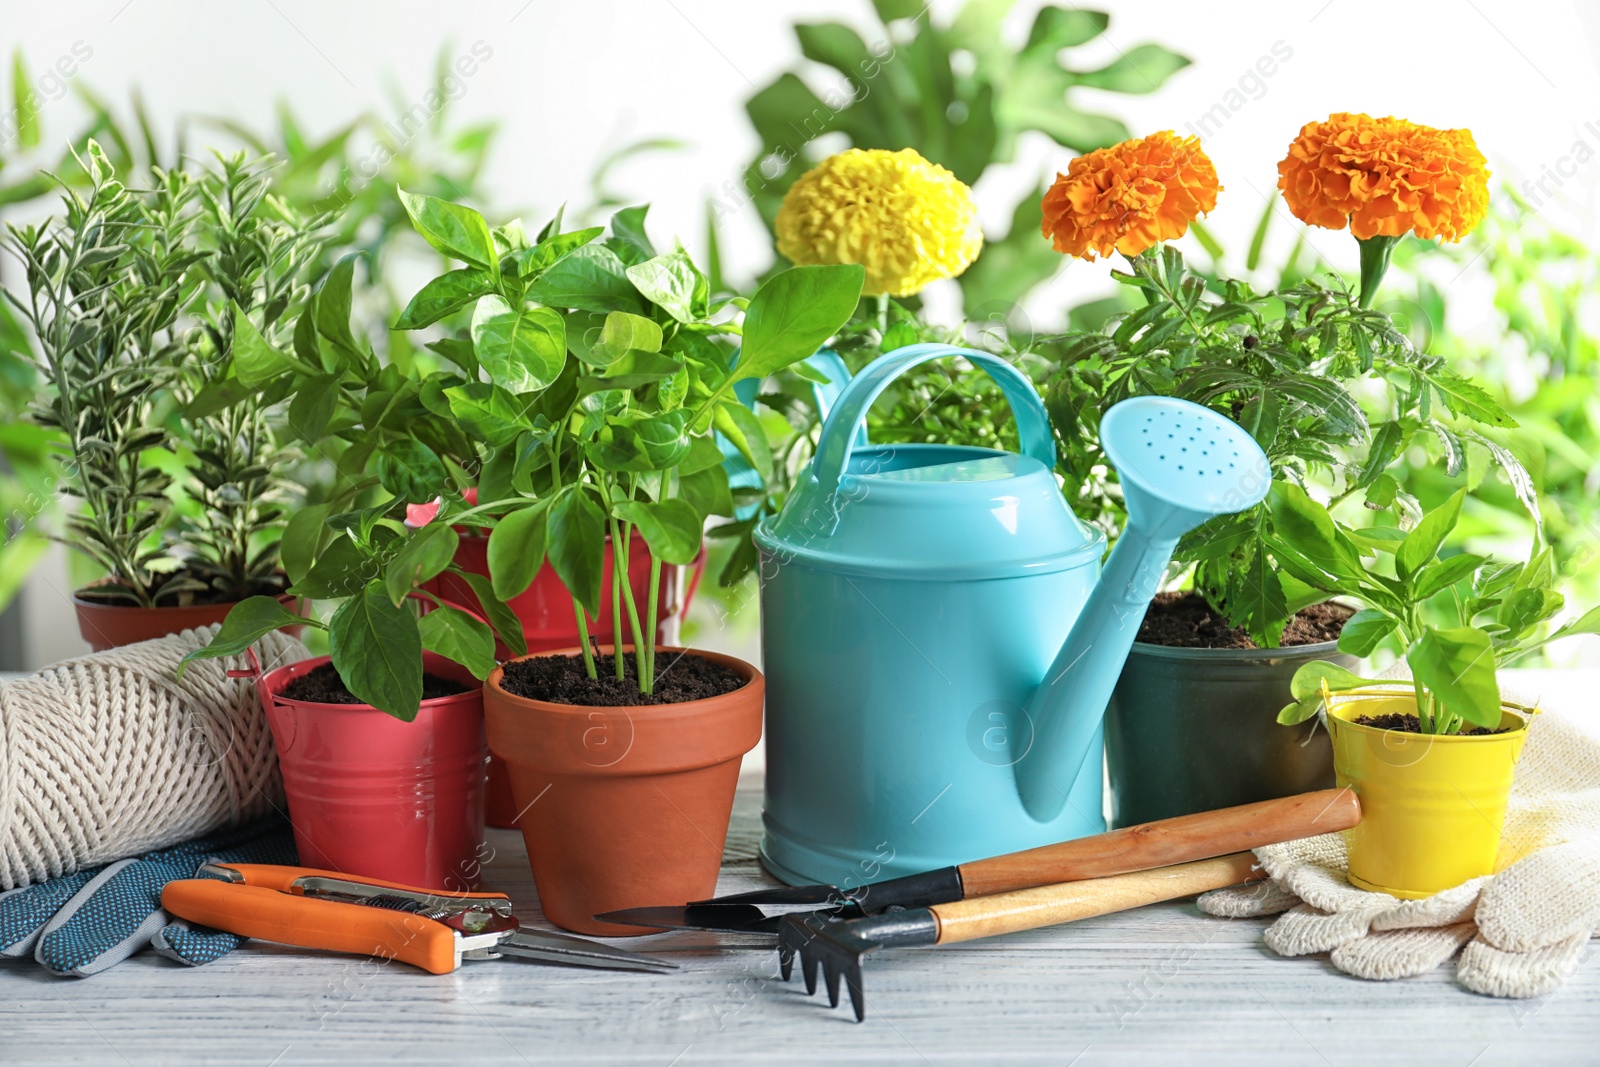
left=1043, top=123, right=1526, bottom=825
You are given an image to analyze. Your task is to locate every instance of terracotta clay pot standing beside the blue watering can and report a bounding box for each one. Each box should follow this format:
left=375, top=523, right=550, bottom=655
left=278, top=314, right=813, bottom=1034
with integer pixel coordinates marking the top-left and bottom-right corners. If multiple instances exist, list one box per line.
left=483, top=648, right=766, bottom=937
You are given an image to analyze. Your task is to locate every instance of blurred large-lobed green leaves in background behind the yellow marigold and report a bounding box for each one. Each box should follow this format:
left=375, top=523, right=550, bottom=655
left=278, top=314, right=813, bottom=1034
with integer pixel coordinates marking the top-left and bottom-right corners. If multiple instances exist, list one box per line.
left=741, top=0, right=1189, bottom=320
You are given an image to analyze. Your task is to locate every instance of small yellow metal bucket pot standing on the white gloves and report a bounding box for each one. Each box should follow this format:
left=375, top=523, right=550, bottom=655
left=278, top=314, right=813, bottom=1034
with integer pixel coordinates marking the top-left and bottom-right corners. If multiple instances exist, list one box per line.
left=1328, top=689, right=1533, bottom=901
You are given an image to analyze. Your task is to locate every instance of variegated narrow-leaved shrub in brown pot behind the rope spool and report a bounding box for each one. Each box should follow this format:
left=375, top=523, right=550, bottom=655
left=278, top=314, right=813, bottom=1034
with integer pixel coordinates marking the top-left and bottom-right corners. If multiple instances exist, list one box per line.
left=6, top=141, right=322, bottom=648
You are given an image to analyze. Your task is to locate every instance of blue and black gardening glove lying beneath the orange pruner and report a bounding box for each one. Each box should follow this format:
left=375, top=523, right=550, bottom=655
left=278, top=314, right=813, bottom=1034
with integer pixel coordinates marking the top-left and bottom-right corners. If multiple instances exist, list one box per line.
left=0, top=819, right=298, bottom=977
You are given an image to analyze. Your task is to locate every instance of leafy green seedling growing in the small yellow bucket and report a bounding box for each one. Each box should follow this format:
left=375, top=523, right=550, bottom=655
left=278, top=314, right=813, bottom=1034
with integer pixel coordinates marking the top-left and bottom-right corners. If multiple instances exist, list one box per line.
left=1269, top=483, right=1600, bottom=734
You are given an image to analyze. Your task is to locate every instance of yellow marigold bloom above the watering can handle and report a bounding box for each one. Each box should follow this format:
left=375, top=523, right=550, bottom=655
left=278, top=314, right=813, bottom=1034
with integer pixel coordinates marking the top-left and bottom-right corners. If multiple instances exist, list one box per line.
left=776, top=149, right=984, bottom=296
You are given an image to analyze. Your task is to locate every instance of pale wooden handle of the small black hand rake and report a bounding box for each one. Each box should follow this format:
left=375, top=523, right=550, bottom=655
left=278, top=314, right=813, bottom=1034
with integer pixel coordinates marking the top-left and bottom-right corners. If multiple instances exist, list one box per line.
left=930, top=853, right=1266, bottom=945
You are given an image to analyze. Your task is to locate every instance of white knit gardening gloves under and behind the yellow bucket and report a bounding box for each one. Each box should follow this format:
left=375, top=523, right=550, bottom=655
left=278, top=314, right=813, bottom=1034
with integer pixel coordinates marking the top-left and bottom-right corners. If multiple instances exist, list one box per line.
left=1198, top=681, right=1600, bottom=997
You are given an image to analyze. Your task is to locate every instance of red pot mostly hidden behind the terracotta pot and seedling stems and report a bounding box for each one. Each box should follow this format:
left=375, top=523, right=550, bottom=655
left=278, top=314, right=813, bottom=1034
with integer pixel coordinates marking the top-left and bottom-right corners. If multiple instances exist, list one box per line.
left=430, top=530, right=706, bottom=829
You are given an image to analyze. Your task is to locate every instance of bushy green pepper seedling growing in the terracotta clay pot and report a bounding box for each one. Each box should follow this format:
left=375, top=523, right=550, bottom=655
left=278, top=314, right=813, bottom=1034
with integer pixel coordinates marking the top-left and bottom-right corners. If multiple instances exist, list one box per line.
left=384, top=192, right=864, bottom=693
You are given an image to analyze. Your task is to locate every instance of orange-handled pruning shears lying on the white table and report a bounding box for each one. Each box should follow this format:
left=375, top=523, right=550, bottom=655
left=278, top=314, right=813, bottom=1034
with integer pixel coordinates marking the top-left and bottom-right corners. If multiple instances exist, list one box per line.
left=162, top=864, right=677, bottom=974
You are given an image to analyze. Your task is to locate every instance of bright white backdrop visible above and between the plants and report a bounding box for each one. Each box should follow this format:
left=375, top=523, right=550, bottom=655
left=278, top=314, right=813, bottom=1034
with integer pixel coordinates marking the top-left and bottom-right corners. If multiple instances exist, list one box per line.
left=0, top=0, right=1600, bottom=661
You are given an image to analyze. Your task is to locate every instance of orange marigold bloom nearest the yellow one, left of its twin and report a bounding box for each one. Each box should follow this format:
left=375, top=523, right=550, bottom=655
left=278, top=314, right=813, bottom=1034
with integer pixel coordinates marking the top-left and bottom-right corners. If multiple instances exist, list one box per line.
left=1040, top=130, right=1222, bottom=259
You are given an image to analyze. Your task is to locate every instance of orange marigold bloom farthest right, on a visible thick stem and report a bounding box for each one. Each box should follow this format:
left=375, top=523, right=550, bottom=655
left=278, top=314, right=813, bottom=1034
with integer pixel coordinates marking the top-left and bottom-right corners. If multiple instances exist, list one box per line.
left=1278, top=112, right=1490, bottom=242
